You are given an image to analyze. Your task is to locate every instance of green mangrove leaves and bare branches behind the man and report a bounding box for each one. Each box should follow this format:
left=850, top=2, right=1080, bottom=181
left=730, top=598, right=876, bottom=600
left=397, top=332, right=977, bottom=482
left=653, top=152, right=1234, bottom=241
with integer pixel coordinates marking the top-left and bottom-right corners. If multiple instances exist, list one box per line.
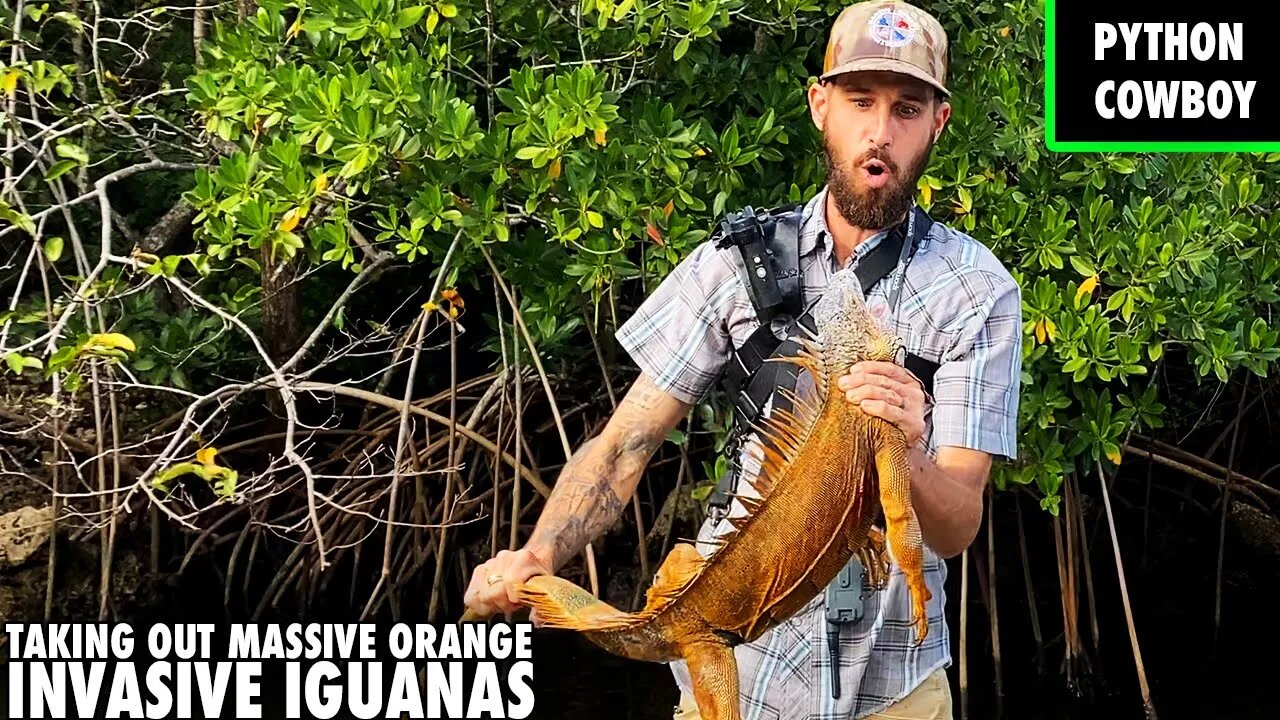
left=0, top=0, right=1280, bottom=712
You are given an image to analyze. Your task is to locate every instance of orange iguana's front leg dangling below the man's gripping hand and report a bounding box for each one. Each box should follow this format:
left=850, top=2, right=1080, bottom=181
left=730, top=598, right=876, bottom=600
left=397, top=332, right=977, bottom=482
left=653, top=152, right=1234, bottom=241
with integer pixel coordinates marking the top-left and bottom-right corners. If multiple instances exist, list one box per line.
left=876, top=438, right=932, bottom=644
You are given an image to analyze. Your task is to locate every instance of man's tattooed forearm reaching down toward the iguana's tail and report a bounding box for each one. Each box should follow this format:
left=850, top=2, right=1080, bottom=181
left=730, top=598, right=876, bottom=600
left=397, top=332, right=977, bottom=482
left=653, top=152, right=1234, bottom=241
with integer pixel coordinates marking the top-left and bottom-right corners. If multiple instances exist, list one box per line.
left=529, top=371, right=681, bottom=570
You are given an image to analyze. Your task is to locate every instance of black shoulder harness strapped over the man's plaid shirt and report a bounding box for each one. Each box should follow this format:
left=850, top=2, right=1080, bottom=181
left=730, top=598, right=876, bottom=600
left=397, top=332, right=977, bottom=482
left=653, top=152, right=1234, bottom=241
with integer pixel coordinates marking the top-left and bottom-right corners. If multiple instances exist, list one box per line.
left=710, top=205, right=938, bottom=512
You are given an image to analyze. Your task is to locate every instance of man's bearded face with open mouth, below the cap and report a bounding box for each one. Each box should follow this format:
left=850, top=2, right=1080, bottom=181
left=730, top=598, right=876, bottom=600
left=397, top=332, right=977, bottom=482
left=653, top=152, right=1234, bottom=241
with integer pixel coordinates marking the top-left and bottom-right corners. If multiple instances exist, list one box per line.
left=809, top=72, right=951, bottom=229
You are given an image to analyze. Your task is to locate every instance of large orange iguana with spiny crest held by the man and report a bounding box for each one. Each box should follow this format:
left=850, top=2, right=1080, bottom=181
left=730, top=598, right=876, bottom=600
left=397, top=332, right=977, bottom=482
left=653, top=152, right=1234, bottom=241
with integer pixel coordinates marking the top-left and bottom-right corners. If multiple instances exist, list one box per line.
left=463, top=270, right=931, bottom=720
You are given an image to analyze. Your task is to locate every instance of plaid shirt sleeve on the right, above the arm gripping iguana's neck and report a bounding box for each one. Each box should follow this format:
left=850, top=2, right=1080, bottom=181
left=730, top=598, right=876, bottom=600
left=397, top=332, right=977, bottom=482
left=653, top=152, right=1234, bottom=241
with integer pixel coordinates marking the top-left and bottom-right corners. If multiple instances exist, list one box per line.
left=932, top=278, right=1023, bottom=460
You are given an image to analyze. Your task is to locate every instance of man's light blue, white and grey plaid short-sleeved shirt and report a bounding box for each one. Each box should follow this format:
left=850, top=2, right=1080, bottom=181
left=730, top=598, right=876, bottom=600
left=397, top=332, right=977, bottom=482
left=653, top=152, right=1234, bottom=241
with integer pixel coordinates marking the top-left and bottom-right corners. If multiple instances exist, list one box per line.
left=617, top=188, right=1021, bottom=720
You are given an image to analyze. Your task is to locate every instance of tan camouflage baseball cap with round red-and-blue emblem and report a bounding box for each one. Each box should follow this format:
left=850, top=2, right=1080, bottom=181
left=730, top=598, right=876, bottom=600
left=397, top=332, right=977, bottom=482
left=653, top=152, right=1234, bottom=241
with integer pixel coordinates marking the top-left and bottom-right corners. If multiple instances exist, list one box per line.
left=822, top=0, right=950, bottom=95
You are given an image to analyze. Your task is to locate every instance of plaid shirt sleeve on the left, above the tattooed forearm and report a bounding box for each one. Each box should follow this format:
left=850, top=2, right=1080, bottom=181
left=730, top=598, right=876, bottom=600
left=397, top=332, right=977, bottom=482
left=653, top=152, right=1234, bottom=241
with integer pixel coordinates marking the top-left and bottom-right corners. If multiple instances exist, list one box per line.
left=616, top=241, right=741, bottom=404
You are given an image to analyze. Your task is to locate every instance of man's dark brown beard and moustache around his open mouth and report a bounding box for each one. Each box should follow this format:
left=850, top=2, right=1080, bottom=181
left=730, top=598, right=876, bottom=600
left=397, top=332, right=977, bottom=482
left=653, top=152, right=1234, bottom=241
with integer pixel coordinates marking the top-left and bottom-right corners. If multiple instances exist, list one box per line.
left=822, top=136, right=933, bottom=229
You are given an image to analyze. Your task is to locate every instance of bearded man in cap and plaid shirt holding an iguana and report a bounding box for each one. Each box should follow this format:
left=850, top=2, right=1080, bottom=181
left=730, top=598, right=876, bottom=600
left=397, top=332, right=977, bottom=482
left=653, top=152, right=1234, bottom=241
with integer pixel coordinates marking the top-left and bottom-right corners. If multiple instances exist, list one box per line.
left=465, top=0, right=1021, bottom=720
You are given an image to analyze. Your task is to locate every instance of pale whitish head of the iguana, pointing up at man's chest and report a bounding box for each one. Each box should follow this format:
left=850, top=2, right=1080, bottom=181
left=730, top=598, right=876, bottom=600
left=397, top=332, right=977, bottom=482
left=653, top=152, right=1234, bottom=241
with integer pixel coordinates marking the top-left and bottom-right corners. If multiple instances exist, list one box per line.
left=813, top=268, right=900, bottom=373
